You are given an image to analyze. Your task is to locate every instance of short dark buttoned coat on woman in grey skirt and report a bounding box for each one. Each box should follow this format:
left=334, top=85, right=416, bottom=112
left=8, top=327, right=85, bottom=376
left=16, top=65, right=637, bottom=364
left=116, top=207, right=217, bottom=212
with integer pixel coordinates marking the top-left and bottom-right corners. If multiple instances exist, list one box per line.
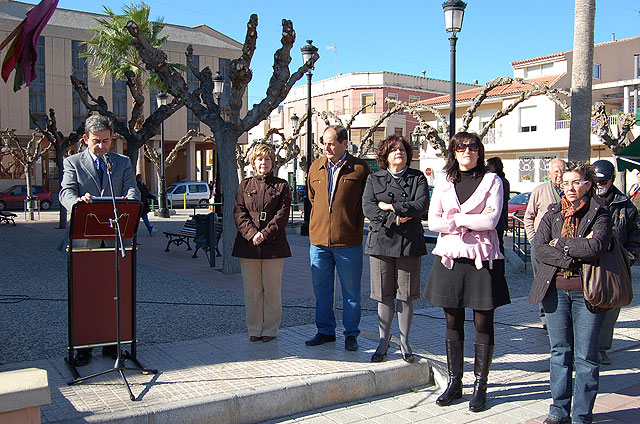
left=362, top=168, right=429, bottom=258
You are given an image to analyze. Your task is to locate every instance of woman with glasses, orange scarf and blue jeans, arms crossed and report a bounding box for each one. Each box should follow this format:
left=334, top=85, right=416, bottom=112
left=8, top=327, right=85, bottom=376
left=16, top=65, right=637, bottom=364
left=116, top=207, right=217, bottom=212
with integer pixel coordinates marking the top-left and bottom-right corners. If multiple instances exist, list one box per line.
left=529, top=161, right=612, bottom=424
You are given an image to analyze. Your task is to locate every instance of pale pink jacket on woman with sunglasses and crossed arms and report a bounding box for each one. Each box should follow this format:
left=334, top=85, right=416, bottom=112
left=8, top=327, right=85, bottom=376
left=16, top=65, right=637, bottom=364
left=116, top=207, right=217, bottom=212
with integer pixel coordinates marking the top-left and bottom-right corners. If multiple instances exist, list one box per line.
left=429, top=172, right=504, bottom=269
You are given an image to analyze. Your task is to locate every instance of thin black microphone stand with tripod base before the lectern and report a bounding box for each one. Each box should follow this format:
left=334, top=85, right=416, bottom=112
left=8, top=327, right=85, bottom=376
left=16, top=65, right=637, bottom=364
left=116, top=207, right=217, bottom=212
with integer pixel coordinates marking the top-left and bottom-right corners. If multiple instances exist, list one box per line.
left=67, top=154, right=158, bottom=401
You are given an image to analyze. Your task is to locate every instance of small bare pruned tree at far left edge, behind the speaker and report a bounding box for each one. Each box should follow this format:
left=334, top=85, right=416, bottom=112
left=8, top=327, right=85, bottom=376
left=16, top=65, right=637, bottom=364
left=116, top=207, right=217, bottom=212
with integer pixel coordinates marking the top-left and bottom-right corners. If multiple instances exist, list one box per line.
left=0, top=129, right=52, bottom=219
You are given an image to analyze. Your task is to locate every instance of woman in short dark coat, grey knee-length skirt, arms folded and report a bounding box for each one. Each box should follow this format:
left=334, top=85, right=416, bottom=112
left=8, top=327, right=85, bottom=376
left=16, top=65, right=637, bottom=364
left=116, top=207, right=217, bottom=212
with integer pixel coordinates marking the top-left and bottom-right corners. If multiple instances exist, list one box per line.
left=362, top=135, right=429, bottom=363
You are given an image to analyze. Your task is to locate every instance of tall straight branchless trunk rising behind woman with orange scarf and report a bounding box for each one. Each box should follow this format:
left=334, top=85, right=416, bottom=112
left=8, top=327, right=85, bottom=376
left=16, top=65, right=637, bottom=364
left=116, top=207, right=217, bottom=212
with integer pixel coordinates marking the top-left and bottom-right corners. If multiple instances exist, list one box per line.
left=569, top=0, right=596, bottom=161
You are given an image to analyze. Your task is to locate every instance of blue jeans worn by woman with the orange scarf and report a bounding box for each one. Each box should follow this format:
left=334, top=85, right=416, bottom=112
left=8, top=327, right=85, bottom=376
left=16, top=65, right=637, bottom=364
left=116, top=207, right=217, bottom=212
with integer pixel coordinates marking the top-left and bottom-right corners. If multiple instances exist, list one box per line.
left=542, top=286, right=604, bottom=423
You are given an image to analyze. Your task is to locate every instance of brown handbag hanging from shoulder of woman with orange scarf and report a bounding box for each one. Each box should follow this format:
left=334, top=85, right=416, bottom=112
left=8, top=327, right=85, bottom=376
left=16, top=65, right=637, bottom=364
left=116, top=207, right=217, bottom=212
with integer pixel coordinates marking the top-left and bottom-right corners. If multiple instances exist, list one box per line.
left=582, top=234, right=633, bottom=313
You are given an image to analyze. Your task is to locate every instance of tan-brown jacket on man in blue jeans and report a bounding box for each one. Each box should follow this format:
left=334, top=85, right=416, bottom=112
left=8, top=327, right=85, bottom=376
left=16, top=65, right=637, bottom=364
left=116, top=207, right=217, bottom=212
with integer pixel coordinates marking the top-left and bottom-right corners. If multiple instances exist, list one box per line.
left=307, top=153, right=369, bottom=246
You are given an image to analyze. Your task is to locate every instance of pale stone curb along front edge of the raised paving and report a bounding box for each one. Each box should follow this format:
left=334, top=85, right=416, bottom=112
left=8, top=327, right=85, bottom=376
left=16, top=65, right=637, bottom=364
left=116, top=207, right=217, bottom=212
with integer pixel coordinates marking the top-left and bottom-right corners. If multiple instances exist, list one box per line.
left=62, top=358, right=435, bottom=424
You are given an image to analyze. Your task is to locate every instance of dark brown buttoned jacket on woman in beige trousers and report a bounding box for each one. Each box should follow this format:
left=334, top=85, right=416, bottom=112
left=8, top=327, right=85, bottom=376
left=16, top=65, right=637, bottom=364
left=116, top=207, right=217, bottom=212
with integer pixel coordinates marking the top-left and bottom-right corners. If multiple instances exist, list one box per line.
left=231, top=173, right=291, bottom=259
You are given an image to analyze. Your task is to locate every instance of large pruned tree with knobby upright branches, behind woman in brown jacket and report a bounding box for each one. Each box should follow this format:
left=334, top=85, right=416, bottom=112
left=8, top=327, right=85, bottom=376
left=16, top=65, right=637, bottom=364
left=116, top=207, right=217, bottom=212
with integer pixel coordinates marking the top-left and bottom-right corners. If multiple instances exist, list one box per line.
left=126, top=14, right=319, bottom=274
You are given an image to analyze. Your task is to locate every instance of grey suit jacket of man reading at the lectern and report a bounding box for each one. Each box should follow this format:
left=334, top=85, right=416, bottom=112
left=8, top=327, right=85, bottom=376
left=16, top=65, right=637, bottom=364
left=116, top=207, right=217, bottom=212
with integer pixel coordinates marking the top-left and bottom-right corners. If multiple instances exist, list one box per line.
left=58, top=149, right=140, bottom=211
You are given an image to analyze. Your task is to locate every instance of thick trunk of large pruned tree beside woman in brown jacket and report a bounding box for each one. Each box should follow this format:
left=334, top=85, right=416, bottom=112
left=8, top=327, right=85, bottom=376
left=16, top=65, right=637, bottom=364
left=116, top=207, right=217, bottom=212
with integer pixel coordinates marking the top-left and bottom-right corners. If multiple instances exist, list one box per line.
left=216, top=128, right=240, bottom=274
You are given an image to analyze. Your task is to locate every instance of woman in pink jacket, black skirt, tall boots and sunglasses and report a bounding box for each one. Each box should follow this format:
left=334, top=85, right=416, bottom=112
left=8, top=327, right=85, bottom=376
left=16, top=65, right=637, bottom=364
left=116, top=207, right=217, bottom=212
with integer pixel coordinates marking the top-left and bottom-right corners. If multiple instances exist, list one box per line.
left=424, top=132, right=510, bottom=412
